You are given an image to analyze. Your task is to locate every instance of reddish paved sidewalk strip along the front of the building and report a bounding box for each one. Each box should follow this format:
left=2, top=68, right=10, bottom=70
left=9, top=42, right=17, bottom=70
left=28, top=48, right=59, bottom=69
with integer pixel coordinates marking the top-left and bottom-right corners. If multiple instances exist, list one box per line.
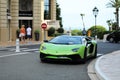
left=0, top=40, right=41, bottom=48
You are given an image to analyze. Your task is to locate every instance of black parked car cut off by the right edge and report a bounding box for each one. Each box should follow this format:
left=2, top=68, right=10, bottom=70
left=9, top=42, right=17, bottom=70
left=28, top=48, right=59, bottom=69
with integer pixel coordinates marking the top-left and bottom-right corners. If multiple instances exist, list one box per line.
left=106, top=30, right=120, bottom=43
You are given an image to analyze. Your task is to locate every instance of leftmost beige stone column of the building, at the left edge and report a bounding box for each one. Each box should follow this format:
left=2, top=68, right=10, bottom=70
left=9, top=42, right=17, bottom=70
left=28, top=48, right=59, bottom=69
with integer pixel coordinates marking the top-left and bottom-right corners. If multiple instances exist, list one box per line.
left=0, top=0, right=8, bottom=42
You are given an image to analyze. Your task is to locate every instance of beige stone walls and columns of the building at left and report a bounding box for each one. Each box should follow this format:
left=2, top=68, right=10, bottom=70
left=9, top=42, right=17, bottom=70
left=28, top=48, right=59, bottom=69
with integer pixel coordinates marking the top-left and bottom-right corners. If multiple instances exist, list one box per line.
left=0, top=0, right=56, bottom=42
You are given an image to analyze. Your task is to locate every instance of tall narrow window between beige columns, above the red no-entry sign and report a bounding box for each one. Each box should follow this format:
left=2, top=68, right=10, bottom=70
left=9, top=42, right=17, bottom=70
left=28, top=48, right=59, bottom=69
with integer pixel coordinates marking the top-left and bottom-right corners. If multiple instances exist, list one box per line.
left=44, top=0, right=51, bottom=19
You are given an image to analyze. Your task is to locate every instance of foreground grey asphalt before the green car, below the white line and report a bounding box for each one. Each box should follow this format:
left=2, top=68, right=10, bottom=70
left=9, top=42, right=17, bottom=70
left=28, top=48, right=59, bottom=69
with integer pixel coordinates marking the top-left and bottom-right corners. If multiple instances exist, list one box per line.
left=0, top=52, right=90, bottom=80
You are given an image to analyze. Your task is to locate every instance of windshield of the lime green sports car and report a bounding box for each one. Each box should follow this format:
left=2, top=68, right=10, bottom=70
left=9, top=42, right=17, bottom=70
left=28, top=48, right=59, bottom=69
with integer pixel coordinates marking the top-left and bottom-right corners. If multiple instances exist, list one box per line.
left=49, top=36, right=82, bottom=44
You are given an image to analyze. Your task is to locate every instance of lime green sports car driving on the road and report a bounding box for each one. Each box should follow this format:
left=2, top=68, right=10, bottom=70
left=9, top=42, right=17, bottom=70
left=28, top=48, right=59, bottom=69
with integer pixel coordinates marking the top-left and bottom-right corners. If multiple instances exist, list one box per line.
left=40, top=35, right=97, bottom=62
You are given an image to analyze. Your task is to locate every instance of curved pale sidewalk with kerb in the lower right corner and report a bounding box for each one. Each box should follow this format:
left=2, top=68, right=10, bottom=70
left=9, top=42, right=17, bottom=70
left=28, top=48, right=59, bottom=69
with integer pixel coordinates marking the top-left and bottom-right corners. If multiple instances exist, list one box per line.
left=95, top=50, right=120, bottom=80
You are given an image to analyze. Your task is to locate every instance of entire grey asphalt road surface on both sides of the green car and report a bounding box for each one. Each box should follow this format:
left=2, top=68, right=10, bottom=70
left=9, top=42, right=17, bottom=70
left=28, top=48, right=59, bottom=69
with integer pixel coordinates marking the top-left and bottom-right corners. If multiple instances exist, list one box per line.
left=0, top=42, right=120, bottom=80
